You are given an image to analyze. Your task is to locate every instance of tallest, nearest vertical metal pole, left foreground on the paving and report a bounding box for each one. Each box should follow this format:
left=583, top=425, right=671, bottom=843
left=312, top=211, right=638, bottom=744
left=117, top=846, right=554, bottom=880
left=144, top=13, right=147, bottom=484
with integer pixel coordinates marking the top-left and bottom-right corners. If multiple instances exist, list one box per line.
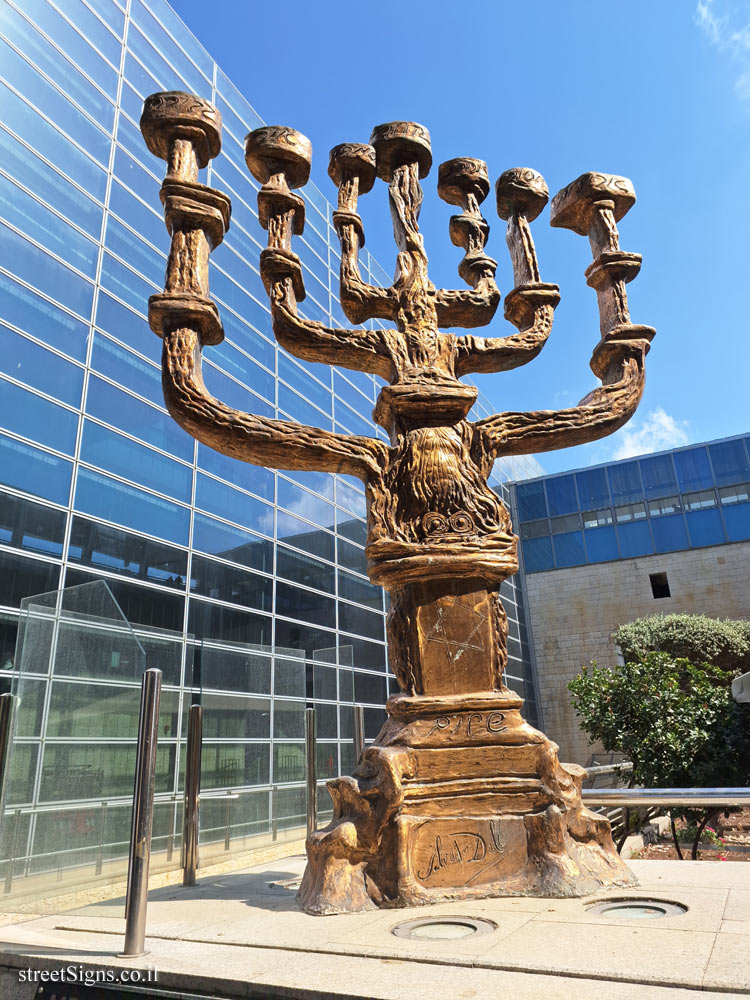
left=122, top=668, right=161, bottom=958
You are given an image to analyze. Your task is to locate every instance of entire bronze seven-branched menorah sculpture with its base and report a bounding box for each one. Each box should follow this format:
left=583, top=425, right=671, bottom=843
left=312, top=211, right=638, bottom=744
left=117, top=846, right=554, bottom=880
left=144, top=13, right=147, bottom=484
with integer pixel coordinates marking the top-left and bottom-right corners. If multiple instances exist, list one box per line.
left=141, top=93, right=654, bottom=913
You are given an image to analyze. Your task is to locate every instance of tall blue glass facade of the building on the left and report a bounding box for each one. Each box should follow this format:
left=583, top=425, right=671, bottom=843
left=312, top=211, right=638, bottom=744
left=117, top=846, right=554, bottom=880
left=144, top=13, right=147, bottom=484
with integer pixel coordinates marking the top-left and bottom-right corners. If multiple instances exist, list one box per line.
left=0, top=0, right=540, bottom=880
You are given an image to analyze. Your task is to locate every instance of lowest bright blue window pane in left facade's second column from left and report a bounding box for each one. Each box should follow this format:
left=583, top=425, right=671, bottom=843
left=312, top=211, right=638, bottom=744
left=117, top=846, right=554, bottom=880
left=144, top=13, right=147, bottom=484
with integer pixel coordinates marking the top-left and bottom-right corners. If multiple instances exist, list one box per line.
left=76, top=468, right=190, bottom=545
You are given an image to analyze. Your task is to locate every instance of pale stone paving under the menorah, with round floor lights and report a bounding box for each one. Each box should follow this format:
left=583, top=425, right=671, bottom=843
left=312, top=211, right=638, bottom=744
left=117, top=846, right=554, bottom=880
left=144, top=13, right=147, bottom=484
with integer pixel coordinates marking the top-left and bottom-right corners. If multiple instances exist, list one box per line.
left=0, top=857, right=750, bottom=1000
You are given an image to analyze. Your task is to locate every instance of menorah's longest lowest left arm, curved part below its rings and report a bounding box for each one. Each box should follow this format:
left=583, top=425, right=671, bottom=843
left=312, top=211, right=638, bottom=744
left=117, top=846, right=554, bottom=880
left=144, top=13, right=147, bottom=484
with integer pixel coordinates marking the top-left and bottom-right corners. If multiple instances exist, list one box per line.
left=162, top=327, right=387, bottom=481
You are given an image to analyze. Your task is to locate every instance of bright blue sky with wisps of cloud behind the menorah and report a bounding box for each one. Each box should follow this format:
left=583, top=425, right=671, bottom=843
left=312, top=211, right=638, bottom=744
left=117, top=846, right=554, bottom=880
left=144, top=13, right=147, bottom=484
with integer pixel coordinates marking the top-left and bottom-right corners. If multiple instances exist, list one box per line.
left=172, top=0, right=750, bottom=472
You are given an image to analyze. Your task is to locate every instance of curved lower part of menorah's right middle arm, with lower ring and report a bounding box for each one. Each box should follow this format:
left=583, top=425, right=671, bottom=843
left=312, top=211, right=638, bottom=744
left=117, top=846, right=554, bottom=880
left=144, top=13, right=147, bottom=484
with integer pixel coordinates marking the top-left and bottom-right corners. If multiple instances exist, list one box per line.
left=456, top=282, right=560, bottom=378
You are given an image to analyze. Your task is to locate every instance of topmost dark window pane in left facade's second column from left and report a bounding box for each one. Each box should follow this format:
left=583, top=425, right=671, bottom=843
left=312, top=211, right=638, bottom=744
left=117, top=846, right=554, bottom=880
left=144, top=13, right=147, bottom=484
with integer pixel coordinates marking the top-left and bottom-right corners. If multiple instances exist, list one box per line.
left=68, top=516, right=187, bottom=588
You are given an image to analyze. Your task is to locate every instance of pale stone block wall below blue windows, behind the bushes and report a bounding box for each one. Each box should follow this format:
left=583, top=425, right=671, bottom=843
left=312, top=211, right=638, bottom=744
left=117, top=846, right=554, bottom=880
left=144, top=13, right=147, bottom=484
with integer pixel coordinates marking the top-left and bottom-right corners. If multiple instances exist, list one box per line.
left=526, top=542, right=750, bottom=764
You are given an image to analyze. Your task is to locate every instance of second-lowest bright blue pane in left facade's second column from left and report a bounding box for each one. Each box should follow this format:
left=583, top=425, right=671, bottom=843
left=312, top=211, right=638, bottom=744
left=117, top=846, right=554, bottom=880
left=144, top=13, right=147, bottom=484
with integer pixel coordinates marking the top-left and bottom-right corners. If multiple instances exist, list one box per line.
left=81, top=420, right=193, bottom=501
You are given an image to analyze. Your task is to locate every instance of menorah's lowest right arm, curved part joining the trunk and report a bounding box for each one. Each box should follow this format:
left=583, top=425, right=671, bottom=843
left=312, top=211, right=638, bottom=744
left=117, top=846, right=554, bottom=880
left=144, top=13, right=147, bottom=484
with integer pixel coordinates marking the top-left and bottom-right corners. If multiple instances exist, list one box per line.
left=482, top=338, right=653, bottom=458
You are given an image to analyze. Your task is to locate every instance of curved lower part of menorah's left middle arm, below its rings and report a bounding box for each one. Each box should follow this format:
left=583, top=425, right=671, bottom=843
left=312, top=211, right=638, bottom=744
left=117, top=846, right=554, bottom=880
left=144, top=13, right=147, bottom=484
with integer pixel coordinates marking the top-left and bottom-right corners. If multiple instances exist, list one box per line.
left=268, top=268, right=394, bottom=380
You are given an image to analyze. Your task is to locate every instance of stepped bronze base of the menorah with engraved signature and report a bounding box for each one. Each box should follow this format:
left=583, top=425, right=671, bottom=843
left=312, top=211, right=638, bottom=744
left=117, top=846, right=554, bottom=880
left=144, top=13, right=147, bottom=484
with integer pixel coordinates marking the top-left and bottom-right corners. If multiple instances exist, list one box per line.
left=297, top=692, right=636, bottom=914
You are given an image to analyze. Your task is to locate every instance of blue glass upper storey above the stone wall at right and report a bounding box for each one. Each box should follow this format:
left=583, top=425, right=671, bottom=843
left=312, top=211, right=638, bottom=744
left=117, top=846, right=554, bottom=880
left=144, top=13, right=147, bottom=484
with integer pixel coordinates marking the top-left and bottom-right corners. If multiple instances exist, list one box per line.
left=513, top=436, right=750, bottom=573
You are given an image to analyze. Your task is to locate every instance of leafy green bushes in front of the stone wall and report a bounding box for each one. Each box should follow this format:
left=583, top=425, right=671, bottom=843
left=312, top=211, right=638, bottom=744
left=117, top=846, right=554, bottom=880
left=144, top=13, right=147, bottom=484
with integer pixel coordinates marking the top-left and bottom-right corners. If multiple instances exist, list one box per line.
left=568, top=615, right=750, bottom=856
